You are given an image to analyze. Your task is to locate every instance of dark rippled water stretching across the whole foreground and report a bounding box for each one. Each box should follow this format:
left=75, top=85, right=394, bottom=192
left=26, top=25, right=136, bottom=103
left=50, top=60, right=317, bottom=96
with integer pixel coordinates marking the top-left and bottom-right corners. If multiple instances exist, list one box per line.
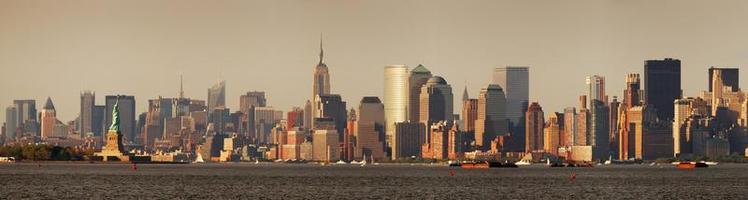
left=0, top=162, right=748, bottom=199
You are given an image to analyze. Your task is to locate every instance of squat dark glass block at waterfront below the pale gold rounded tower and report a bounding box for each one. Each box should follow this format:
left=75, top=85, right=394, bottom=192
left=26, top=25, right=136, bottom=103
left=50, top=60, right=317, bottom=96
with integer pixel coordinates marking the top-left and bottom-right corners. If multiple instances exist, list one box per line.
left=392, top=122, right=427, bottom=160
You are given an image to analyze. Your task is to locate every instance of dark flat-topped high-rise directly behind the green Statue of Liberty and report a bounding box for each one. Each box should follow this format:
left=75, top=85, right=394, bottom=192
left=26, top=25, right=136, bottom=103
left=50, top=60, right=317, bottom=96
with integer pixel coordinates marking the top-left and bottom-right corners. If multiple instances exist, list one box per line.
left=105, top=95, right=136, bottom=142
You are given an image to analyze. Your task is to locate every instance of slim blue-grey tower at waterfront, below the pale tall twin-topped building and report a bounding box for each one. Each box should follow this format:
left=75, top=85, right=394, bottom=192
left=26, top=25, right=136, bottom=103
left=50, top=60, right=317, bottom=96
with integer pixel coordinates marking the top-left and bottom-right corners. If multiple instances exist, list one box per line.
left=587, top=100, right=610, bottom=160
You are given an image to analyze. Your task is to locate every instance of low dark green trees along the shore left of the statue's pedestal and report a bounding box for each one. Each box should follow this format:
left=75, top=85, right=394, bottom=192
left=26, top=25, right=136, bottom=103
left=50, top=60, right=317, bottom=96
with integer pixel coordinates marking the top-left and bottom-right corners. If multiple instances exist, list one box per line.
left=0, top=144, right=94, bottom=161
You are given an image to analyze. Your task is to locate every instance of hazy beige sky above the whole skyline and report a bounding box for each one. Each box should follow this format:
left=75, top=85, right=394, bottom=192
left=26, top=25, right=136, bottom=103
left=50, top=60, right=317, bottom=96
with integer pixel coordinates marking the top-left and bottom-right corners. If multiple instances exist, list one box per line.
left=0, top=0, right=748, bottom=121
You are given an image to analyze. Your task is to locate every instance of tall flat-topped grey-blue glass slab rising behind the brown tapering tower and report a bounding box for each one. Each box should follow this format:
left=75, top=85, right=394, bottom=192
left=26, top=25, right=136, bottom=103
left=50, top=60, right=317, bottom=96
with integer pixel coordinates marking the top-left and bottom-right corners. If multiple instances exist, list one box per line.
left=493, top=66, right=530, bottom=124
